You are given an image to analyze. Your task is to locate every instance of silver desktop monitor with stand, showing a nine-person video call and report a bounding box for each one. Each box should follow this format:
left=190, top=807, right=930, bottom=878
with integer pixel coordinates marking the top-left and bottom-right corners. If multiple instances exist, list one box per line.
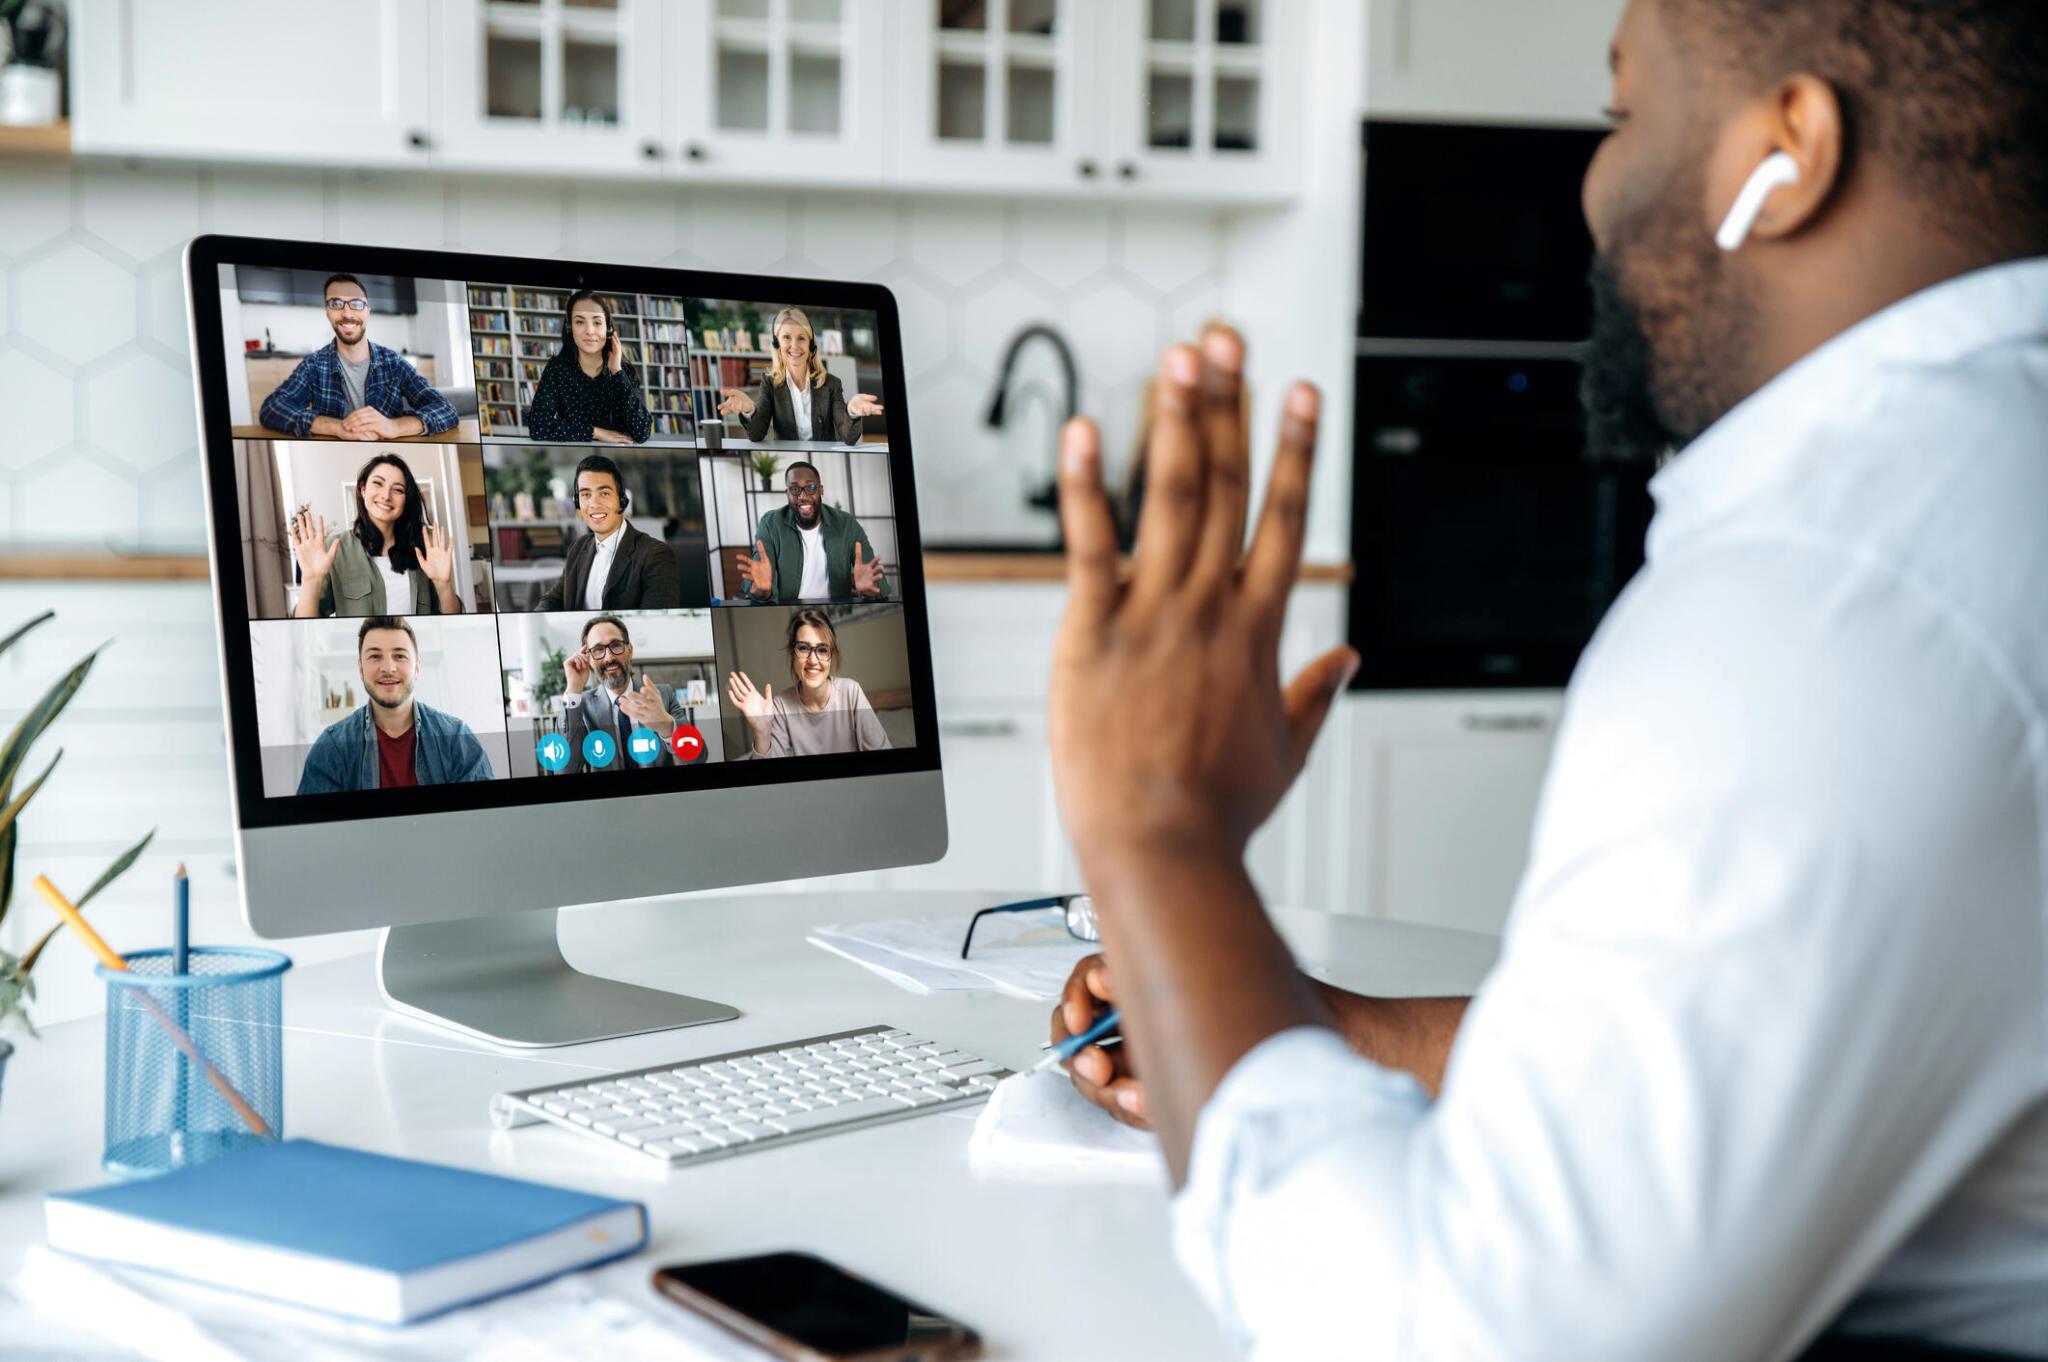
left=186, top=236, right=946, bottom=1045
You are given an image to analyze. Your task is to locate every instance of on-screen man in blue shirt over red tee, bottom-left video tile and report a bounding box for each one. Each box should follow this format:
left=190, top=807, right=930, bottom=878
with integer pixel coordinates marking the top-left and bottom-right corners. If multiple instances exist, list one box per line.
left=299, top=614, right=492, bottom=795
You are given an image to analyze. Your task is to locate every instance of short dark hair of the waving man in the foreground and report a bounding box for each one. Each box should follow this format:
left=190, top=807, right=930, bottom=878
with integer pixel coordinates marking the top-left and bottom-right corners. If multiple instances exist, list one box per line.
left=1663, top=0, right=2048, bottom=254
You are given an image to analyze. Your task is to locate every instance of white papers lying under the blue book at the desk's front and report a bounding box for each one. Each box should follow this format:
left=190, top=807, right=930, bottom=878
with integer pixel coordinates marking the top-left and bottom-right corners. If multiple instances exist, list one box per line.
left=0, top=1245, right=762, bottom=1362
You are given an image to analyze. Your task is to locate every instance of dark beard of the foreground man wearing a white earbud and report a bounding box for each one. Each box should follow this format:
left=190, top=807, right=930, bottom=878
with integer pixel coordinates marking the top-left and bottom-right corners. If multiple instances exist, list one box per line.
left=1579, top=186, right=1749, bottom=463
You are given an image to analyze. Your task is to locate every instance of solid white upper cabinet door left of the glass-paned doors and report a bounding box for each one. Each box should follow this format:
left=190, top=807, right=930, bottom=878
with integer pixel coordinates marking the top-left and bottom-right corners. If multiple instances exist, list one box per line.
left=72, top=0, right=440, bottom=166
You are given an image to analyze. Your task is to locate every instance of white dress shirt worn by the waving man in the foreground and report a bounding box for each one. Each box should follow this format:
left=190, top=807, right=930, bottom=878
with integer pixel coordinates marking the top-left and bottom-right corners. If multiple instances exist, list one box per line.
left=1174, top=260, right=2048, bottom=1362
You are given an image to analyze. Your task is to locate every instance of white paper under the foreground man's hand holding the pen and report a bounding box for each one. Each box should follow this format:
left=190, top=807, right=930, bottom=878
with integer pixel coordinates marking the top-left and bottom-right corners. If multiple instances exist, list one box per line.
left=967, top=1069, right=1165, bottom=1182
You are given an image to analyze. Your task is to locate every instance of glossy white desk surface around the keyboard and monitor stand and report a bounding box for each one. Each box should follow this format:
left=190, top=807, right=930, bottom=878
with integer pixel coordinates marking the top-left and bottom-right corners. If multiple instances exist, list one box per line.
left=0, top=891, right=1497, bottom=1362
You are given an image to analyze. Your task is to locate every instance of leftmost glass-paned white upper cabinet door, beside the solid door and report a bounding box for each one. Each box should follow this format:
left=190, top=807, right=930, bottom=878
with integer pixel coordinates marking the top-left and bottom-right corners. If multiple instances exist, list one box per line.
left=436, top=0, right=666, bottom=176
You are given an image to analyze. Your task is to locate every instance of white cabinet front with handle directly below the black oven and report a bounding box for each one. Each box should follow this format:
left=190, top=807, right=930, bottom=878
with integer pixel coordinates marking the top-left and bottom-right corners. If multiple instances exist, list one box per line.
left=1346, top=690, right=1563, bottom=932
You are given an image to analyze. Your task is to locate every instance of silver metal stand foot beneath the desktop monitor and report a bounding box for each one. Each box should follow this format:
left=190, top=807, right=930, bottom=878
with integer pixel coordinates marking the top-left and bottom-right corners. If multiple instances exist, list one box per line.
left=377, top=909, right=739, bottom=1047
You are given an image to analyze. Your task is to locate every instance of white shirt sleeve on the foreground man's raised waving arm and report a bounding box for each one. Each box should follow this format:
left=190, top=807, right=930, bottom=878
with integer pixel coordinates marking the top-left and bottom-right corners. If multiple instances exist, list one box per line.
left=1174, top=545, right=2048, bottom=1362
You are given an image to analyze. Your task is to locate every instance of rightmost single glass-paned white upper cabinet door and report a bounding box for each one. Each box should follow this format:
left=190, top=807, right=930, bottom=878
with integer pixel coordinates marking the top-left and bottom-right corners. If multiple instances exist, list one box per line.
left=1096, top=0, right=1311, bottom=201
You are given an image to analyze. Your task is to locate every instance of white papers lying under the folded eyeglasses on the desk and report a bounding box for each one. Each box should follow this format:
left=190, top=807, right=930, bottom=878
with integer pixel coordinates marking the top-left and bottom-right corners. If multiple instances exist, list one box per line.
left=811, top=907, right=1096, bottom=1002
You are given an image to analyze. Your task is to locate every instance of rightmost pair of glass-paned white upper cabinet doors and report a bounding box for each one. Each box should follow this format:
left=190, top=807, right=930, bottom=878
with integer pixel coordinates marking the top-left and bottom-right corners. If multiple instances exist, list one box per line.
left=895, top=0, right=1300, bottom=201
